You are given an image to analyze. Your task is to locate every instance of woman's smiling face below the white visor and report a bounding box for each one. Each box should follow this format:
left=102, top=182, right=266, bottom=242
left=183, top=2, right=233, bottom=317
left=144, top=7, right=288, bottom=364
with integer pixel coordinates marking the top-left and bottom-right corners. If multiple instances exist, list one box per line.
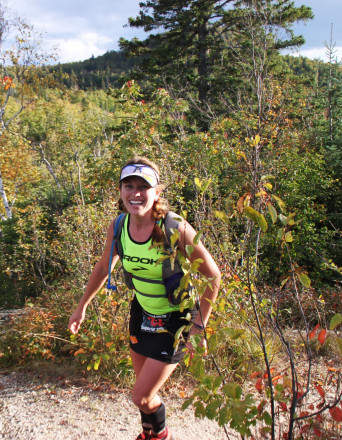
left=120, top=177, right=160, bottom=216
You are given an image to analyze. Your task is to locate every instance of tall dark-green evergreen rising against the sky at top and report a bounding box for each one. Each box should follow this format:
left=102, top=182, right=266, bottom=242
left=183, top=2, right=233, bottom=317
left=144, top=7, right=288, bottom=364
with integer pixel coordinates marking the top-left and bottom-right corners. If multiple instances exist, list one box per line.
left=120, top=0, right=312, bottom=117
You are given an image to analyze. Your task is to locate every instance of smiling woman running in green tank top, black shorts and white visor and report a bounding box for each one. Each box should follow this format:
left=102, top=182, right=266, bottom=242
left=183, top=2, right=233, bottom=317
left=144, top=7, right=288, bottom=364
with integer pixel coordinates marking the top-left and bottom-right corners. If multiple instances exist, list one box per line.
left=69, top=157, right=221, bottom=440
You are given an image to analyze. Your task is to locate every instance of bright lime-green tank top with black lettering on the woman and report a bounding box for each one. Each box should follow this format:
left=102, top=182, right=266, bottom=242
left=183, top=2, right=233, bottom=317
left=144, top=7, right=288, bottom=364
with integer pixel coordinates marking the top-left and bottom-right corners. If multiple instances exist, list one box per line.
left=121, top=215, right=179, bottom=315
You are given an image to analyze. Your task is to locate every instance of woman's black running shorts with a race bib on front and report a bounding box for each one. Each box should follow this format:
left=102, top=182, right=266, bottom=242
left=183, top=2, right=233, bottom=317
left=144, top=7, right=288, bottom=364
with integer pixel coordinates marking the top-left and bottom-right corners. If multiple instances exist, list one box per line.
left=129, top=297, right=197, bottom=364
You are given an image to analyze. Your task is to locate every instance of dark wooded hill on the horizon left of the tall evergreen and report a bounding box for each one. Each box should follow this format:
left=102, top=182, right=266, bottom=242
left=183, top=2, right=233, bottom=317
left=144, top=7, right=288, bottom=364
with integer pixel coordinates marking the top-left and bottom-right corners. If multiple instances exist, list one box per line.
left=50, top=50, right=134, bottom=90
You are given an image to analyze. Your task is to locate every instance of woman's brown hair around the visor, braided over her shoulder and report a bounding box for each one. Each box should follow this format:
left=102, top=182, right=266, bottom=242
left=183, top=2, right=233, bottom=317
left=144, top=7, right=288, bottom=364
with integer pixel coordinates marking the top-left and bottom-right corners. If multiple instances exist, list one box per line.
left=118, top=156, right=169, bottom=243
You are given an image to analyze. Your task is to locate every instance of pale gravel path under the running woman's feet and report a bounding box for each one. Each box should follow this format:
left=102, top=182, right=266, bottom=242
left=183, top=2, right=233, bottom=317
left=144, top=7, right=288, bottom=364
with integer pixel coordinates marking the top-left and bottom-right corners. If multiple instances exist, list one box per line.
left=0, top=372, right=240, bottom=440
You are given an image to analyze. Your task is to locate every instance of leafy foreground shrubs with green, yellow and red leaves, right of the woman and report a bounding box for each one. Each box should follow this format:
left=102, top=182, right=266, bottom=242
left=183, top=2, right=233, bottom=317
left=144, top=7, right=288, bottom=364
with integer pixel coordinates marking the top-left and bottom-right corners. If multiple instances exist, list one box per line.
left=183, top=138, right=342, bottom=439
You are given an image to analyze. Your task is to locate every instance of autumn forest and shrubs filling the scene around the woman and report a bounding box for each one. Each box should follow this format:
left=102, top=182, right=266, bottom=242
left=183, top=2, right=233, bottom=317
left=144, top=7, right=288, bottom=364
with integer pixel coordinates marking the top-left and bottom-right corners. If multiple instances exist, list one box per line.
left=0, top=0, right=342, bottom=439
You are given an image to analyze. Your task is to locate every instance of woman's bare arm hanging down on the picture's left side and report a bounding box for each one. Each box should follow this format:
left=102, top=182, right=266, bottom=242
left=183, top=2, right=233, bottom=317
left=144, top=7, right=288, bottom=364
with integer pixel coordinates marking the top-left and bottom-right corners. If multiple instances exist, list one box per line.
left=69, top=220, right=119, bottom=335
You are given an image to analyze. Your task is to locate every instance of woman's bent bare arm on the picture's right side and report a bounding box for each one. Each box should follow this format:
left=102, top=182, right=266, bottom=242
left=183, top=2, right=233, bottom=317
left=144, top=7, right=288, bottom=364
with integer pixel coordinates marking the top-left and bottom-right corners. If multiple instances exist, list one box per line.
left=178, top=221, right=221, bottom=334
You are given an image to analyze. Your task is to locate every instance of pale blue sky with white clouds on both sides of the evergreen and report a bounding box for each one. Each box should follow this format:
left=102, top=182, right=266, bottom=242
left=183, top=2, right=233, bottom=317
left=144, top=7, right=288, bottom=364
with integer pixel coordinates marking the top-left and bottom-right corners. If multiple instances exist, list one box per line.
left=8, top=0, right=342, bottom=63
